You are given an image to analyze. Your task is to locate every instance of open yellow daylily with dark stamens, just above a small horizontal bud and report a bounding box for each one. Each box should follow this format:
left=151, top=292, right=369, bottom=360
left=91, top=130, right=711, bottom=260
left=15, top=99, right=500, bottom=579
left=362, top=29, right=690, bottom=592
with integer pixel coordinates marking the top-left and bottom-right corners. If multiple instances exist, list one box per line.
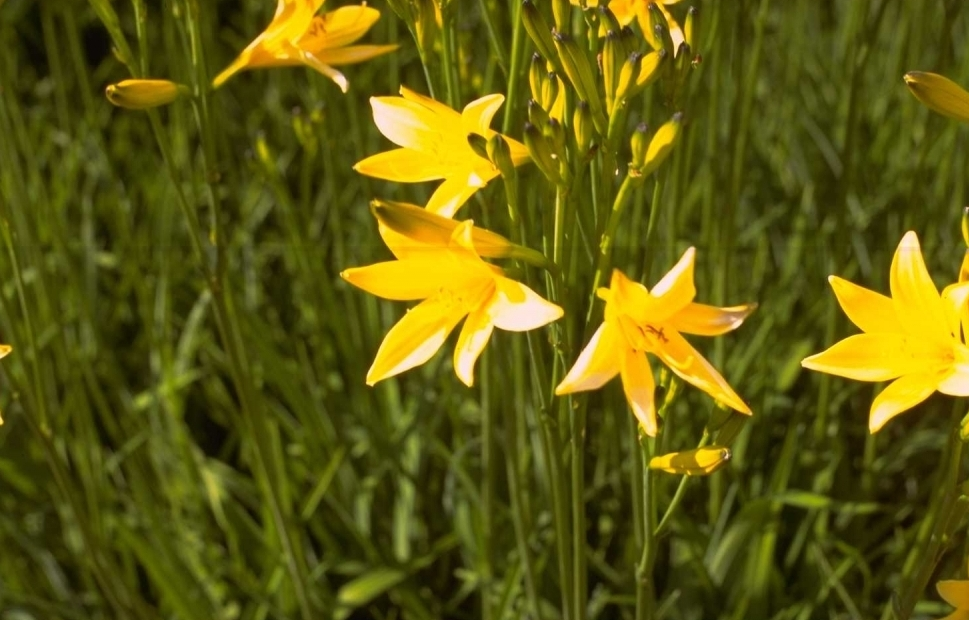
left=555, top=248, right=757, bottom=437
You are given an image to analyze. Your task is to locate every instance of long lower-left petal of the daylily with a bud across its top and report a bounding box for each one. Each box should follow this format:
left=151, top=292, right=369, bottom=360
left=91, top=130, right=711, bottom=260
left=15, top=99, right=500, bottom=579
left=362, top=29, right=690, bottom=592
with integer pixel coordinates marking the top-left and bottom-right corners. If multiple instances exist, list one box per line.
left=367, top=296, right=465, bottom=385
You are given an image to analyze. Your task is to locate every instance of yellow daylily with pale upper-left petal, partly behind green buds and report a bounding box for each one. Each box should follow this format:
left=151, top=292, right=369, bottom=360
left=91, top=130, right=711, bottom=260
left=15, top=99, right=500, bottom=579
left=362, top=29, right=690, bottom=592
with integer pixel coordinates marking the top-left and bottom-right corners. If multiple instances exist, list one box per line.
left=353, top=86, right=529, bottom=217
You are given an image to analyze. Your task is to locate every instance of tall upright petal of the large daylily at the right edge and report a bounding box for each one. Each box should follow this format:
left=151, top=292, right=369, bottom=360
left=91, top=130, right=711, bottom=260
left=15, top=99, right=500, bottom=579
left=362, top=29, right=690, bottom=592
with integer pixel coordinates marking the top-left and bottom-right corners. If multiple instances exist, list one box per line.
left=890, top=231, right=948, bottom=341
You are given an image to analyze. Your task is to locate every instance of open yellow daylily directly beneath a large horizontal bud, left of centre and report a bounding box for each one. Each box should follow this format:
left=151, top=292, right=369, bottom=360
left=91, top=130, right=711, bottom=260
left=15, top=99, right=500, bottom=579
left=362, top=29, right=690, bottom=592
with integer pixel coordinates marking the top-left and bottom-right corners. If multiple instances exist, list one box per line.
left=340, top=220, right=563, bottom=387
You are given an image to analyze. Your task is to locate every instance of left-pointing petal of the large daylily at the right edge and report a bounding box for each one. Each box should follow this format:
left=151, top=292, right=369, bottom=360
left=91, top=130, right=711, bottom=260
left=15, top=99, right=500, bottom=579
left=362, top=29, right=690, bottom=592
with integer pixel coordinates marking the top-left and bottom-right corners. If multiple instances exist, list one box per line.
left=801, top=333, right=951, bottom=381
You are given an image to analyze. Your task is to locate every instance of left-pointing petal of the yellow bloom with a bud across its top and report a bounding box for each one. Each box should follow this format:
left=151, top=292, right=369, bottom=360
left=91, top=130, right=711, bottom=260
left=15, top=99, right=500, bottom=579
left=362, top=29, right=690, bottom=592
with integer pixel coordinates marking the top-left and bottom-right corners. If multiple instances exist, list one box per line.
left=340, top=258, right=466, bottom=301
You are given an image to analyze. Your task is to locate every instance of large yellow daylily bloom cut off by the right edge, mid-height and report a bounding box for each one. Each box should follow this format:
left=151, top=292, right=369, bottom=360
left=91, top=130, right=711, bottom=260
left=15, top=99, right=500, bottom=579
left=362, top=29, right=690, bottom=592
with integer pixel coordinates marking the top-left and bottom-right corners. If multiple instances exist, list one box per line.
left=801, top=231, right=969, bottom=433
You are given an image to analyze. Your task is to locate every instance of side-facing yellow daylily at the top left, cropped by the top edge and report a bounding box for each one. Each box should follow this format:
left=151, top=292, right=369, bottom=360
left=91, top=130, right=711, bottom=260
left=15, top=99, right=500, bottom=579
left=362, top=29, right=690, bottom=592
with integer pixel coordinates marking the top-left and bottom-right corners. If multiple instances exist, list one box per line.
left=212, top=0, right=397, bottom=92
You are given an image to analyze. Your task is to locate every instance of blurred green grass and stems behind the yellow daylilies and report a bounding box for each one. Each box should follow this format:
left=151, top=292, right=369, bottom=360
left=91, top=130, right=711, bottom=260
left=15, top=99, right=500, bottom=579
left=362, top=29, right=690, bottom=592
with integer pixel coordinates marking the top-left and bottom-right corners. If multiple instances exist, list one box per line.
left=0, top=0, right=969, bottom=620
